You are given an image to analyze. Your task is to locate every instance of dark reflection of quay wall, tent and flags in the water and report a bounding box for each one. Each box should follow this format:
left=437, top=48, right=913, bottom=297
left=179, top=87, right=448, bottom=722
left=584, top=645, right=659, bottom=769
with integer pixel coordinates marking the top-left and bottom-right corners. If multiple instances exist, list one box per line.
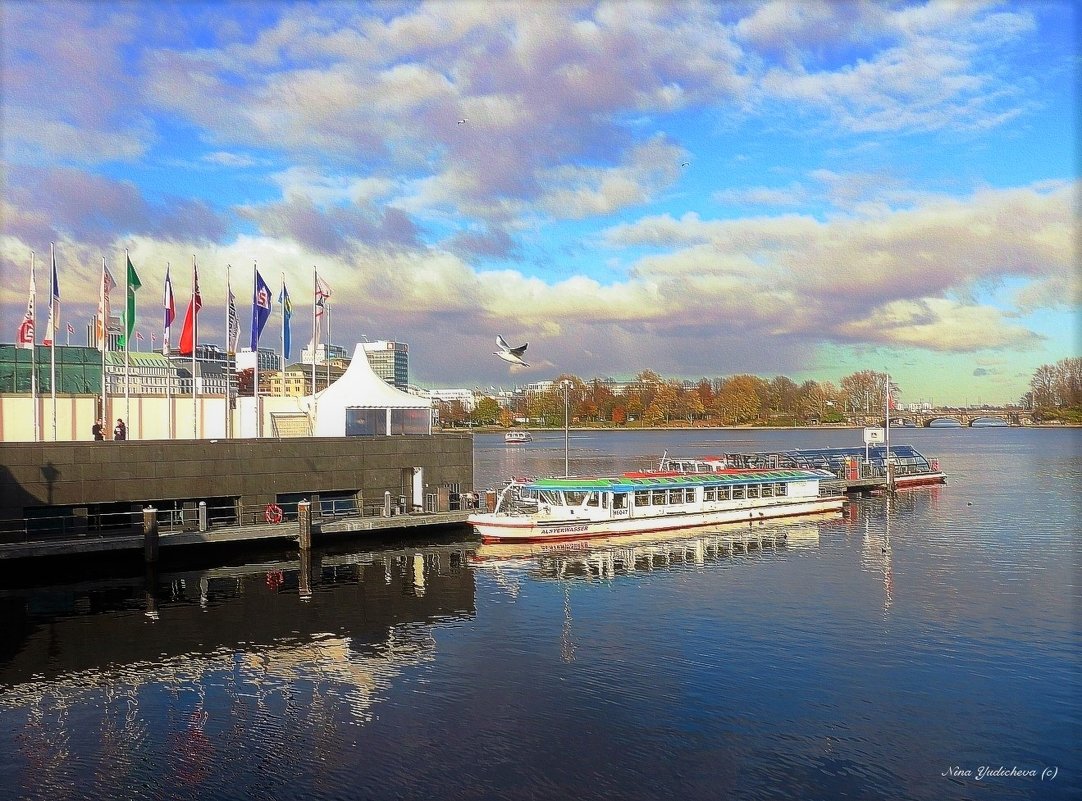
left=0, top=546, right=475, bottom=796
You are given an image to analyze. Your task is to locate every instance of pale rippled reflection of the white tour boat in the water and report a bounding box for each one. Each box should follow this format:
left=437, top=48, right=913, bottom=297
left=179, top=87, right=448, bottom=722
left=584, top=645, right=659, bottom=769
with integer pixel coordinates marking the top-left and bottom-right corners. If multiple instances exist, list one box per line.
left=470, top=514, right=837, bottom=580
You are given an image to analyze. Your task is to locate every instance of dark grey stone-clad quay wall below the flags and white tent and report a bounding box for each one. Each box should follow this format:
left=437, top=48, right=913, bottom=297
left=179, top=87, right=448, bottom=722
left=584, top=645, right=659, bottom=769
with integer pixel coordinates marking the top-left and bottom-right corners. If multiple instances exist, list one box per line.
left=0, top=433, right=473, bottom=522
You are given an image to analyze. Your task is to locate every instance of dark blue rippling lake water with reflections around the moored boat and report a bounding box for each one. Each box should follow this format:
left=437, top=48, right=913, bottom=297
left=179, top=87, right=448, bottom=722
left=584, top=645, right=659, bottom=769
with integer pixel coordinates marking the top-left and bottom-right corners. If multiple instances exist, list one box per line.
left=0, top=429, right=1082, bottom=800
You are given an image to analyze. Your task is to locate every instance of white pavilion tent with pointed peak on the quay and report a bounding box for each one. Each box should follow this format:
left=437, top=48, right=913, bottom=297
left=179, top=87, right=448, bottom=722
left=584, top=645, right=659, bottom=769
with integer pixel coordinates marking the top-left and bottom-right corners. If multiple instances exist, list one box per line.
left=313, top=344, right=432, bottom=436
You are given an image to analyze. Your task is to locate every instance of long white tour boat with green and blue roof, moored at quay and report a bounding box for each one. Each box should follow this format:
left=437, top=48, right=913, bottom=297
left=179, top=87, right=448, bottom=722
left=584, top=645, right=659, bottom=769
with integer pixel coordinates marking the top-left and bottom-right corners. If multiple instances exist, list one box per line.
left=469, top=470, right=845, bottom=542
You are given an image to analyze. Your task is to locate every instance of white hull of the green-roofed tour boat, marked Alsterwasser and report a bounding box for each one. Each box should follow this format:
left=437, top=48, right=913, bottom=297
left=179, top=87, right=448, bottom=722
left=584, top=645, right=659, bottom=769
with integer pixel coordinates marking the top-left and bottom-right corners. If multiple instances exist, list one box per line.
left=469, top=496, right=845, bottom=543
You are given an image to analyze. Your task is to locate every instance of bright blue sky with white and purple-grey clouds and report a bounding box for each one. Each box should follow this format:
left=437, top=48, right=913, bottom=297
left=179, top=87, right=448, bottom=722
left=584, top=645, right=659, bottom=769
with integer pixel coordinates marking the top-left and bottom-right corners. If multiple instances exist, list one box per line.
left=0, top=0, right=1082, bottom=404
